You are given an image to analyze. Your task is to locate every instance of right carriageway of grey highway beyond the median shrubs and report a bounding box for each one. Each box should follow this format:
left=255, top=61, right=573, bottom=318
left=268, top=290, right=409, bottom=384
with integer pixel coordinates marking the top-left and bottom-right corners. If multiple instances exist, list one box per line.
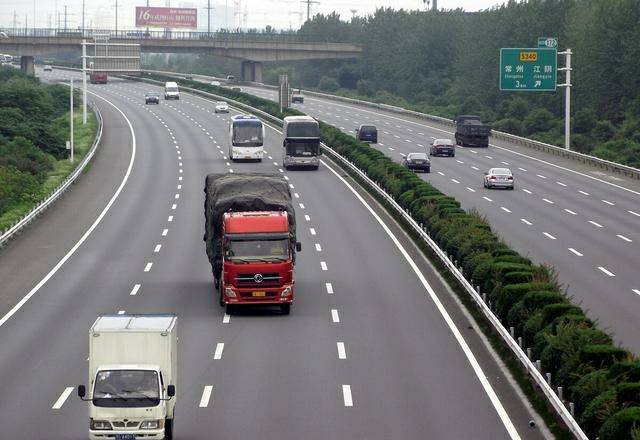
left=238, top=87, right=640, bottom=353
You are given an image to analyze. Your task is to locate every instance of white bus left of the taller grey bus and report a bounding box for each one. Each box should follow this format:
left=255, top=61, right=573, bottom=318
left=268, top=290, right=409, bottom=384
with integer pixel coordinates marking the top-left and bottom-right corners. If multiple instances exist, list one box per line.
left=229, top=115, right=264, bottom=161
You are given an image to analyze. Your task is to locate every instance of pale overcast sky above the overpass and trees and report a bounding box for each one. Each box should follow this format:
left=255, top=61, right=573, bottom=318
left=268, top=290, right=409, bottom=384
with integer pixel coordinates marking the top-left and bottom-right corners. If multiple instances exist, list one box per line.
left=0, top=0, right=505, bottom=30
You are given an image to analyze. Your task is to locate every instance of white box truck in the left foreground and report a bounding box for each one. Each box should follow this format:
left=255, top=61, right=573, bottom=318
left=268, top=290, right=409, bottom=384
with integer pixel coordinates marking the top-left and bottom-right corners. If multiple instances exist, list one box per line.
left=78, top=315, right=178, bottom=440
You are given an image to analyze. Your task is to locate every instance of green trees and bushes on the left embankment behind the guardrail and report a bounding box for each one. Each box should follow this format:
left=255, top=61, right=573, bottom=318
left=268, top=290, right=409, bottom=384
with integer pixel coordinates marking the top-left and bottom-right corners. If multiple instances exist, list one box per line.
left=0, top=67, right=69, bottom=220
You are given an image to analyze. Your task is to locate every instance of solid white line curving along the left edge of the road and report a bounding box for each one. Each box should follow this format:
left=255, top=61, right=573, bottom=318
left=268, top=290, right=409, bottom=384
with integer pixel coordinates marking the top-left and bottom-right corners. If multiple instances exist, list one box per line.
left=0, top=92, right=136, bottom=327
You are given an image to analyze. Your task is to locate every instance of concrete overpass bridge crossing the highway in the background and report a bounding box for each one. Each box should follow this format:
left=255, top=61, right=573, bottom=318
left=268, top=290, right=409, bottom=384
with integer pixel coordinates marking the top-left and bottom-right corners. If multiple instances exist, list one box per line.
left=0, top=29, right=362, bottom=82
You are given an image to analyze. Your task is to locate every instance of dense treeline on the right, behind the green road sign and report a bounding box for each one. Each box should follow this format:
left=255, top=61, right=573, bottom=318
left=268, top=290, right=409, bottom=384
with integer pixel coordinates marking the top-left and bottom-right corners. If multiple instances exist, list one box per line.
left=264, top=0, right=640, bottom=166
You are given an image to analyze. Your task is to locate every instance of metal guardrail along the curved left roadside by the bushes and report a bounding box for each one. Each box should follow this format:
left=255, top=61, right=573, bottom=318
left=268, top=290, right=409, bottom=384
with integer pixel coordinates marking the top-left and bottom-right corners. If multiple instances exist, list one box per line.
left=0, top=102, right=103, bottom=248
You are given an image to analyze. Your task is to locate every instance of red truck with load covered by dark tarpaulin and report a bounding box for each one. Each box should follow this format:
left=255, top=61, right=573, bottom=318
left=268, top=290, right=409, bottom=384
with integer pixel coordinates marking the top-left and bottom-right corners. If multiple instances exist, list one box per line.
left=204, top=173, right=301, bottom=315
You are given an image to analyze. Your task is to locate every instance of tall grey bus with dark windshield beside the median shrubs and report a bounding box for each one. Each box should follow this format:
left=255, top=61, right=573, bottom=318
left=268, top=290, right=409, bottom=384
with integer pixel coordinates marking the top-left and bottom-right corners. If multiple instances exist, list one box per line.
left=282, top=116, right=322, bottom=170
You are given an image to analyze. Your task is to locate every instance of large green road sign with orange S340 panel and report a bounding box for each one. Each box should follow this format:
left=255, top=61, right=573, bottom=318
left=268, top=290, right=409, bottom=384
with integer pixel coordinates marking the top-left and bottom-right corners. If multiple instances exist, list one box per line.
left=500, top=48, right=558, bottom=92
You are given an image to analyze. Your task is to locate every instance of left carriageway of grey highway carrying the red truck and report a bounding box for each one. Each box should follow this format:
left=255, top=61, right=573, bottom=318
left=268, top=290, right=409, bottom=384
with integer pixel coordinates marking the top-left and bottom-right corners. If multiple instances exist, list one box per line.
left=0, top=71, right=545, bottom=440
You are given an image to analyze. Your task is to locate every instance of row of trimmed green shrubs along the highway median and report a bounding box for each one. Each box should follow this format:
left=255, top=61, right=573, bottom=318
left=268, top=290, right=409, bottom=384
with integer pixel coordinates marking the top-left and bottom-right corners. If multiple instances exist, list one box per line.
left=150, top=75, right=640, bottom=440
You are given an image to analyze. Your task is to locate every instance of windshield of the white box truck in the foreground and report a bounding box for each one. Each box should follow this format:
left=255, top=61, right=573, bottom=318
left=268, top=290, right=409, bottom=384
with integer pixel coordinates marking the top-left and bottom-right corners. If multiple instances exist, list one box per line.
left=93, top=370, right=160, bottom=408
